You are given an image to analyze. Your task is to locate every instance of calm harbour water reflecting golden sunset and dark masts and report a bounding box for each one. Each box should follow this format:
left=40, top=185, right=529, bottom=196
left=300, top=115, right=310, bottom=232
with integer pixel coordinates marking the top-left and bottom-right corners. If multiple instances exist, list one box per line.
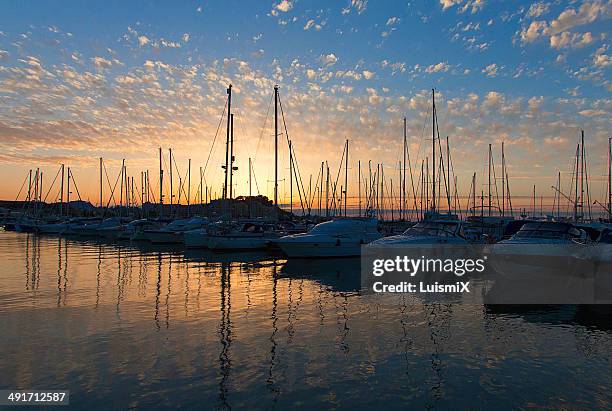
left=0, top=231, right=612, bottom=410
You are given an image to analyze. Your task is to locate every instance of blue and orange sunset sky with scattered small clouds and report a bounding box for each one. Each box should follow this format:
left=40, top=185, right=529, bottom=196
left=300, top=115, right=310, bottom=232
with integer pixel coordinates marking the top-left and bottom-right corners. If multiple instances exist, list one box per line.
left=0, top=0, right=612, bottom=212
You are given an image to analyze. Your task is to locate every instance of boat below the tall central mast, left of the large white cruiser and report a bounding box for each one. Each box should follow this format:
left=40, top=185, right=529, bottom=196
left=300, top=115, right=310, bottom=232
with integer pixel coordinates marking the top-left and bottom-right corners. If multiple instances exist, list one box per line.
left=207, top=221, right=279, bottom=251
